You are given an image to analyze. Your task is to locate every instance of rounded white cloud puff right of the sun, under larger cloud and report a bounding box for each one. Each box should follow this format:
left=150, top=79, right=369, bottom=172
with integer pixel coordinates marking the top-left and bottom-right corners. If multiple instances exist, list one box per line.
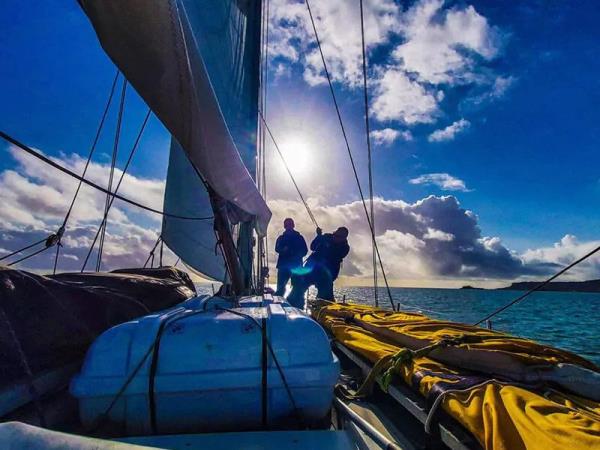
left=372, top=69, right=439, bottom=125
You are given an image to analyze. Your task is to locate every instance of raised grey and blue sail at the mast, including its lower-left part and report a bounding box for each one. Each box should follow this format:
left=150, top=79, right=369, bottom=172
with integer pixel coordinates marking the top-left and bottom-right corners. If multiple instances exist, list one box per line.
left=80, top=0, right=271, bottom=278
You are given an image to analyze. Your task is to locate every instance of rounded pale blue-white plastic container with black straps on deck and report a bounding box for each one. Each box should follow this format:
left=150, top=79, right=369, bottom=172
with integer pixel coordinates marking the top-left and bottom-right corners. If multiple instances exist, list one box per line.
left=71, top=298, right=339, bottom=435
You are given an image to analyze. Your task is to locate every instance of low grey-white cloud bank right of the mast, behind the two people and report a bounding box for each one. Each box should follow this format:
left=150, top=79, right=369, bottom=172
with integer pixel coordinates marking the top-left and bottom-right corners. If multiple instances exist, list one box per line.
left=269, top=196, right=557, bottom=280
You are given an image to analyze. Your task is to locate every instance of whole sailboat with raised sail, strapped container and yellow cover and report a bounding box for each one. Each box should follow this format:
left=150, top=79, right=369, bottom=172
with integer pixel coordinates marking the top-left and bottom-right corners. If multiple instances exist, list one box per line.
left=0, top=0, right=600, bottom=449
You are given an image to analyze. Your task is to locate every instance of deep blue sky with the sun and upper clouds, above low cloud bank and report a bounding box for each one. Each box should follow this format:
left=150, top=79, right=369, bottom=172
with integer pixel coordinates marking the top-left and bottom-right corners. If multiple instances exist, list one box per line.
left=0, top=0, right=600, bottom=284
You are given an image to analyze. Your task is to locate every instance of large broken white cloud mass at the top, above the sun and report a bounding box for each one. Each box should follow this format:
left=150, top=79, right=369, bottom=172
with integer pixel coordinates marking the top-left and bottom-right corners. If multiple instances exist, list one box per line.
left=269, top=0, right=512, bottom=130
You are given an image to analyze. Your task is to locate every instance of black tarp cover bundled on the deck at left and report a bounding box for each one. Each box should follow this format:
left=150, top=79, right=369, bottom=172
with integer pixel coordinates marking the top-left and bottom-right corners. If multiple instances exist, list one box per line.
left=0, top=266, right=196, bottom=388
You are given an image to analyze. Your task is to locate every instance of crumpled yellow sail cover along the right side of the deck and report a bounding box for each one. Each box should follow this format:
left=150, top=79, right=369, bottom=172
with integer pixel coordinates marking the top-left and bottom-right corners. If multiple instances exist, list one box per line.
left=313, top=304, right=600, bottom=450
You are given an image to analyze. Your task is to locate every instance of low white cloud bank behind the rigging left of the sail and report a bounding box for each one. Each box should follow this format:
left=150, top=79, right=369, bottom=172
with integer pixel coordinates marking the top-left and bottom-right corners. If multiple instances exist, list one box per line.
left=0, top=148, right=169, bottom=270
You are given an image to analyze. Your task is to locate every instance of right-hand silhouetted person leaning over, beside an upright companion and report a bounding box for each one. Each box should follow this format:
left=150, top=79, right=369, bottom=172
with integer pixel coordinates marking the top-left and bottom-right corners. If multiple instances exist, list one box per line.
left=287, top=227, right=350, bottom=309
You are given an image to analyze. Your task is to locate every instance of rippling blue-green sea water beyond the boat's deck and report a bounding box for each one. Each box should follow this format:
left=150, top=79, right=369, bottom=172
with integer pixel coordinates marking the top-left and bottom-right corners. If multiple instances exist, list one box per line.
left=198, top=287, right=600, bottom=364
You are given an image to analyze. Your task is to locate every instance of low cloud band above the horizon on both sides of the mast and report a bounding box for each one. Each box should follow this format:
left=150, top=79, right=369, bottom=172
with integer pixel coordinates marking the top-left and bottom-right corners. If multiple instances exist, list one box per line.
left=0, top=146, right=600, bottom=280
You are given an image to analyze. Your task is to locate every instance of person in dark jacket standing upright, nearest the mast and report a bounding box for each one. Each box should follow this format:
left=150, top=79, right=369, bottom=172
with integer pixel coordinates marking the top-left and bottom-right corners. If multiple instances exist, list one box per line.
left=275, top=218, right=308, bottom=296
